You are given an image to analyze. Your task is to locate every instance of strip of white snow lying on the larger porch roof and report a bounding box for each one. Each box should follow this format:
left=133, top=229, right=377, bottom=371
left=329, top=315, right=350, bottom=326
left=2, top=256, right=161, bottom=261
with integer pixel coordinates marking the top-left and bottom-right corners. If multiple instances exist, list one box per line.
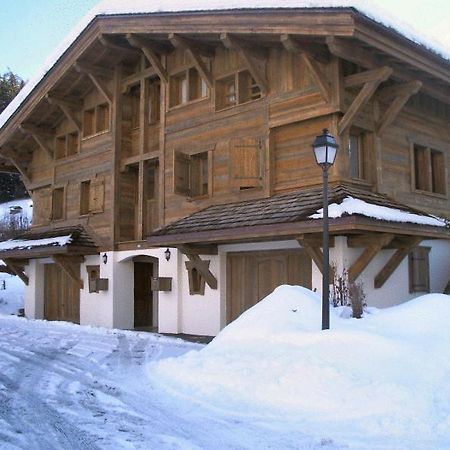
left=309, top=197, right=446, bottom=227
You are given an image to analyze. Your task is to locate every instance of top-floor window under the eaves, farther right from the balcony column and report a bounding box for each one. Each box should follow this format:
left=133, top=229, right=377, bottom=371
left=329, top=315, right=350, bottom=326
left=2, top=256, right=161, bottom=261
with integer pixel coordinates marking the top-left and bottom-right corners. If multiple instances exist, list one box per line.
left=216, top=70, right=261, bottom=110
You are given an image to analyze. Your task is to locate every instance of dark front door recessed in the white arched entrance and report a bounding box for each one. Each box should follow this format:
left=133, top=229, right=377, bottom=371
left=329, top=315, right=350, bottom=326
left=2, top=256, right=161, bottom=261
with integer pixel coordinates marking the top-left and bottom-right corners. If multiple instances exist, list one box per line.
left=134, top=262, right=154, bottom=328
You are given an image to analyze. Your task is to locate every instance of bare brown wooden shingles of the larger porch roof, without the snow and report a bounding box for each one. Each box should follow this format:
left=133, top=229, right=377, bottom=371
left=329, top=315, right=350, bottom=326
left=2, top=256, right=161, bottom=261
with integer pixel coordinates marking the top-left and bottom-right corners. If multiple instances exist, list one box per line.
left=148, top=185, right=442, bottom=245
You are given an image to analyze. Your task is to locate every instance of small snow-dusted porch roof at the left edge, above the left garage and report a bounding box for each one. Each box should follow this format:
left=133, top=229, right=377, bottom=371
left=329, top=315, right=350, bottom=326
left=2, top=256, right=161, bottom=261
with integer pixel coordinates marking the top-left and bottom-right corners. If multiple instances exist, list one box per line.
left=0, top=226, right=98, bottom=259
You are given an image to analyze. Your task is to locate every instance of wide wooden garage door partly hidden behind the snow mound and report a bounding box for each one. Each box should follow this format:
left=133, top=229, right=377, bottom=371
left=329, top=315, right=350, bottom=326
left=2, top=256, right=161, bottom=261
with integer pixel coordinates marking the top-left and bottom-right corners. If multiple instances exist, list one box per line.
left=227, top=249, right=311, bottom=323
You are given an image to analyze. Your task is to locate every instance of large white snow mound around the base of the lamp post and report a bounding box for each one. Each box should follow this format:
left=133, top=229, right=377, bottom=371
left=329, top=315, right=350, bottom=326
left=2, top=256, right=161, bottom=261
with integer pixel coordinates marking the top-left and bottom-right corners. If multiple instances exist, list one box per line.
left=153, top=286, right=450, bottom=449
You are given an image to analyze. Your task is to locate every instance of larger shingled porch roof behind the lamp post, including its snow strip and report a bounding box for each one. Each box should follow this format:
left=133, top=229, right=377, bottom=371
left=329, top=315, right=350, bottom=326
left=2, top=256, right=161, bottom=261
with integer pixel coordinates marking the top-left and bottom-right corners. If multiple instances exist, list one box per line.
left=147, top=185, right=450, bottom=246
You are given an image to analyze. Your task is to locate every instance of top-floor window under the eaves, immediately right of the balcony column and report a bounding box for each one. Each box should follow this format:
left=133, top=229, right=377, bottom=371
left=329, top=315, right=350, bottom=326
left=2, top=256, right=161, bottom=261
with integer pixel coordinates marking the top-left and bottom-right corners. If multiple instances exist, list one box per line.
left=169, top=67, right=209, bottom=107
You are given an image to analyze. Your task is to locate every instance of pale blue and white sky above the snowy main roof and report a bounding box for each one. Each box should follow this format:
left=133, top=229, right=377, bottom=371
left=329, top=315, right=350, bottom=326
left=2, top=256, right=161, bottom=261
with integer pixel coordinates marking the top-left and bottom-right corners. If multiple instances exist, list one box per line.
left=0, top=0, right=450, bottom=80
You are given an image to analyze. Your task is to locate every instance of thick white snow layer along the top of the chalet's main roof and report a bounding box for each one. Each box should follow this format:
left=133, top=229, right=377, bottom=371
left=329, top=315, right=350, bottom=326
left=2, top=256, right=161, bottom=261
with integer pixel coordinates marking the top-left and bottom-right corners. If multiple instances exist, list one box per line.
left=0, top=0, right=450, bottom=132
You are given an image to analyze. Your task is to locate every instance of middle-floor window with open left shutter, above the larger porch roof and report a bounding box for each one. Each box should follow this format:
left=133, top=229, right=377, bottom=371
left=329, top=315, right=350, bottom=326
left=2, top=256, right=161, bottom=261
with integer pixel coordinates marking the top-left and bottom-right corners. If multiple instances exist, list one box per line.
left=174, top=152, right=209, bottom=197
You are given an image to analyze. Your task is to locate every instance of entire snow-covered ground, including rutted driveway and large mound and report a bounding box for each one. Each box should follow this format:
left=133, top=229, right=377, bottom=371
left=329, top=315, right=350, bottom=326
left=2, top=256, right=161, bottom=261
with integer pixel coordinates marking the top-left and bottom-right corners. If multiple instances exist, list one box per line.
left=0, top=286, right=450, bottom=450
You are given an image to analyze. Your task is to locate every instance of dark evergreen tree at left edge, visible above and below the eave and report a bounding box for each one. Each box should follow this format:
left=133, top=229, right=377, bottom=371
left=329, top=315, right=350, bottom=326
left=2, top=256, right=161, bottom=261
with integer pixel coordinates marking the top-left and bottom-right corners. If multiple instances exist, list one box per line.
left=0, top=70, right=28, bottom=203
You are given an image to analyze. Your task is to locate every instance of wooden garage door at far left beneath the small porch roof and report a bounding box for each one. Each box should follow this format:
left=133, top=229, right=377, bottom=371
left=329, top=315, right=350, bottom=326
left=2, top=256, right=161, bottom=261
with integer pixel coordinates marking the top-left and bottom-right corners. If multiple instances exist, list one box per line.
left=44, top=264, right=80, bottom=323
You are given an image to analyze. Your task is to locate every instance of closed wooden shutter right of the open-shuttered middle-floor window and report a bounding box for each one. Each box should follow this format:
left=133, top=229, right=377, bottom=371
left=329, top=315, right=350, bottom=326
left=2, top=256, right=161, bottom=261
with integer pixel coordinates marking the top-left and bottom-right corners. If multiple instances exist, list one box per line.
left=230, top=138, right=262, bottom=189
